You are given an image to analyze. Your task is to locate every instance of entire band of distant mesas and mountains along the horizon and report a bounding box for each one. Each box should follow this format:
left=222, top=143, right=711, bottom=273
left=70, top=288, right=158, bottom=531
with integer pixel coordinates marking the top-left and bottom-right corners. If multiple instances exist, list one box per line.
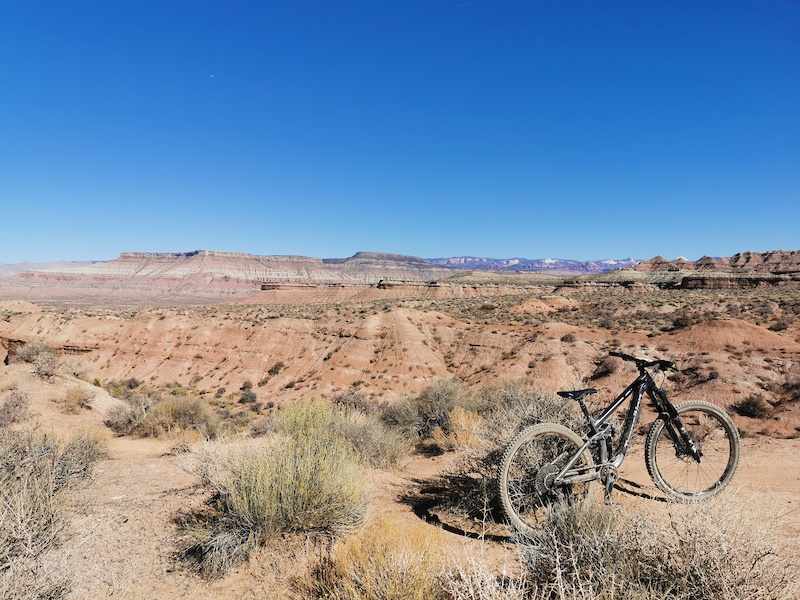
left=0, top=250, right=800, bottom=304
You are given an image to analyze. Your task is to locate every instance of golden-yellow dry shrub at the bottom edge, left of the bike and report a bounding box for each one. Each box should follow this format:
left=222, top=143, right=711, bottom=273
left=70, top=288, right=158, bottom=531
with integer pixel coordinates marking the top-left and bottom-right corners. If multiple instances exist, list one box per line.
left=301, top=517, right=448, bottom=600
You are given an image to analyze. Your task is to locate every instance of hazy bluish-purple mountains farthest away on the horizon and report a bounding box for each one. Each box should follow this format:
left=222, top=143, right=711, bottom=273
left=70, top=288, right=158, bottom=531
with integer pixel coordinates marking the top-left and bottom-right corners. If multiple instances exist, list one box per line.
left=424, top=256, right=639, bottom=275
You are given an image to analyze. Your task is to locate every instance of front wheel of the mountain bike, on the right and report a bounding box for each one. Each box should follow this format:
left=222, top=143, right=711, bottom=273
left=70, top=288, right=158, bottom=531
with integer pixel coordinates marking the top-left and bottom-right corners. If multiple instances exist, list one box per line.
left=645, top=402, right=741, bottom=500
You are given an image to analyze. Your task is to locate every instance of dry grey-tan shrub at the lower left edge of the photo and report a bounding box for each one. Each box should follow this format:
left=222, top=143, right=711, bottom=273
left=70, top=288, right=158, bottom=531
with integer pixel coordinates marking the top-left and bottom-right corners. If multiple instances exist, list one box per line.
left=0, top=429, right=105, bottom=598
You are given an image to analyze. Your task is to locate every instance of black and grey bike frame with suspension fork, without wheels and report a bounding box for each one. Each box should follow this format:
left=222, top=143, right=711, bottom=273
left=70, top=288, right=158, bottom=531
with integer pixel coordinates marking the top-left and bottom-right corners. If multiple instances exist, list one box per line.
left=553, top=368, right=702, bottom=485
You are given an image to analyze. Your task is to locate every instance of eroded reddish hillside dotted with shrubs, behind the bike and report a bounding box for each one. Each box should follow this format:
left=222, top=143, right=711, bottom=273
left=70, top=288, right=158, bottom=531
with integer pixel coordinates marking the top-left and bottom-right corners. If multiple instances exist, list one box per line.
left=0, top=288, right=800, bottom=437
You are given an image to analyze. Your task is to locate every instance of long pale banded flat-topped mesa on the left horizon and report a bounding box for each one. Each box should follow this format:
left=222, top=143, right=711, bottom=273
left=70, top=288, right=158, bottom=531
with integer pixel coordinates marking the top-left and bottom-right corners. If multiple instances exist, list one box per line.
left=0, top=250, right=453, bottom=303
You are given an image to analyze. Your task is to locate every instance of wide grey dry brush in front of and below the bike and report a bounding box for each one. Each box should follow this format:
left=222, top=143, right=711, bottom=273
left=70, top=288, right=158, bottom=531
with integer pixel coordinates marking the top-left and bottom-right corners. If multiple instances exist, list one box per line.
left=521, top=501, right=798, bottom=600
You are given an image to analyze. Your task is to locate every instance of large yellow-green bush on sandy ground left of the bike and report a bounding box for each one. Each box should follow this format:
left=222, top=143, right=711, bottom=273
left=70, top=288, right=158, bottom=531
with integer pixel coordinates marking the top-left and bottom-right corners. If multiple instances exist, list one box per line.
left=185, top=437, right=366, bottom=576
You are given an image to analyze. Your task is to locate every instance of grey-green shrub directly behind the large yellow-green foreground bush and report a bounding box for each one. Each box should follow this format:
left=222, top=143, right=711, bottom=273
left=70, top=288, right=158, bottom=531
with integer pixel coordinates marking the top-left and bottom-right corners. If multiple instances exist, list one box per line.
left=252, top=398, right=411, bottom=468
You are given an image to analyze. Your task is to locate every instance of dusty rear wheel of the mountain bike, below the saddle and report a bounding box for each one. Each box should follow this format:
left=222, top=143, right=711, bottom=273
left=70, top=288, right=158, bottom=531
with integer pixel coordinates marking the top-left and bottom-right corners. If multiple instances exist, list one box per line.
left=498, top=423, right=594, bottom=535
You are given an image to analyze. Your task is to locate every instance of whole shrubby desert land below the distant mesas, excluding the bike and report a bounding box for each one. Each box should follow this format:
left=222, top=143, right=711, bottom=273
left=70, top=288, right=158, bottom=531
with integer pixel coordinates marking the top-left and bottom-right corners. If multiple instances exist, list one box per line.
left=0, top=282, right=800, bottom=600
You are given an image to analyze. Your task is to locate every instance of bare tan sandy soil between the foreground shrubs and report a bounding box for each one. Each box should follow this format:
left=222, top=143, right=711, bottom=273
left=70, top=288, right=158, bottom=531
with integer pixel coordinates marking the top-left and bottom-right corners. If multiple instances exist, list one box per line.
left=0, top=365, right=800, bottom=599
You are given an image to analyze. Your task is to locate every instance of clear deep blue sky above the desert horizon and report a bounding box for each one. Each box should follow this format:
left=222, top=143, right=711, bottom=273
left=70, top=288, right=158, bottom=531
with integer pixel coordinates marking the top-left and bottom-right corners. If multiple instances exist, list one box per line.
left=0, top=0, right=800, bottom=263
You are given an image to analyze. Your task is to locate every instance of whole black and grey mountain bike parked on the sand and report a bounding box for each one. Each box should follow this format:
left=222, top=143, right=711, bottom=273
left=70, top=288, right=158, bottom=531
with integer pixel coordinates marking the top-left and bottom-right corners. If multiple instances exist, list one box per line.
left=498, top=352, right=740, bottom=533
